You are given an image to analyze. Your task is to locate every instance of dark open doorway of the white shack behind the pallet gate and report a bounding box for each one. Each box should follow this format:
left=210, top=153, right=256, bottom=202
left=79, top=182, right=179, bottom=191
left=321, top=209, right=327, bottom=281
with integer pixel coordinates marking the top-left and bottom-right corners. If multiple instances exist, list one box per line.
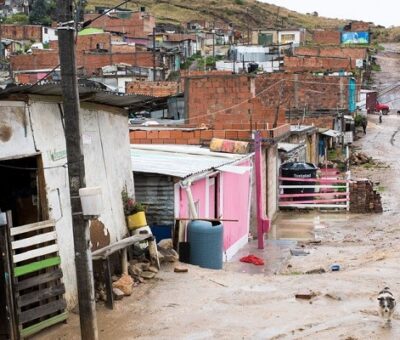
left=0, top=155, right=48, bottom=339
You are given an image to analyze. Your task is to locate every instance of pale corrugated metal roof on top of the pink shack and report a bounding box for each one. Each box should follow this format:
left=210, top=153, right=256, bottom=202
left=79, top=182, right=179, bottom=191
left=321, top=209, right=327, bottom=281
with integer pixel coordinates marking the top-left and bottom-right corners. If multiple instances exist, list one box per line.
left=131, top=145, right=248, bottom=179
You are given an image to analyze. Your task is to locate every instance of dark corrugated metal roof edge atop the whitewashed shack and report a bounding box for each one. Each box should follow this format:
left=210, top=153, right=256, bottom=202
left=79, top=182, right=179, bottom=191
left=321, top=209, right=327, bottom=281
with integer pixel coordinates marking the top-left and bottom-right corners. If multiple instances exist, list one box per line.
left=0, top=82, right=154, bottom=107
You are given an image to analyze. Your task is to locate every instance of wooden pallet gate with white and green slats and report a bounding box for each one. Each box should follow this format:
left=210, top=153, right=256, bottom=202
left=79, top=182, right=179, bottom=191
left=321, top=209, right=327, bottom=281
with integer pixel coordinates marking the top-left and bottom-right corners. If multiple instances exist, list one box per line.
left=10, top=221, right=68, bottom=337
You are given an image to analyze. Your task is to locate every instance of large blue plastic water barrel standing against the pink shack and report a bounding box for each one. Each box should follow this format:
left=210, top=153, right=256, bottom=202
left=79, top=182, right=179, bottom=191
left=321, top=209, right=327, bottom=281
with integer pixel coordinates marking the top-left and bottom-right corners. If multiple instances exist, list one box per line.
left=188, top=221, right=223, bottom=269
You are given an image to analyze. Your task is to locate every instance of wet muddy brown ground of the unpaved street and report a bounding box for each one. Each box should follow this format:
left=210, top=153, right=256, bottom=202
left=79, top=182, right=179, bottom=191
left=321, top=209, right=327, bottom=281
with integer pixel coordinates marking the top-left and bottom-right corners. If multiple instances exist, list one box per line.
left=37, top=45, right=400, bottom=340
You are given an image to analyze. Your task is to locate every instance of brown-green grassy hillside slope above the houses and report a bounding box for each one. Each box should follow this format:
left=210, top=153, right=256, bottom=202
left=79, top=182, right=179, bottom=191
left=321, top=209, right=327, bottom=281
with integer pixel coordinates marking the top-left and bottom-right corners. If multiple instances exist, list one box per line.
left=88, top=0, right=346, bottom=29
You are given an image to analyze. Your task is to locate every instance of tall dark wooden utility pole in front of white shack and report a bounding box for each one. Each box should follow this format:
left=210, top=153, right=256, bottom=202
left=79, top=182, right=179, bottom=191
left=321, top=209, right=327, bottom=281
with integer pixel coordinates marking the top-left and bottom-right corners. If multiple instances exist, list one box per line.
left=58, top=0, right=98, bottom=340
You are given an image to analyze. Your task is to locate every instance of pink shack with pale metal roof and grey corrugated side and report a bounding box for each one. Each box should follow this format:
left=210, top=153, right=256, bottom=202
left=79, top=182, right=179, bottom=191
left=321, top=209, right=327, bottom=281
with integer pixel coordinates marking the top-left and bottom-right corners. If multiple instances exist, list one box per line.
left=131, top=144, right=253, bottom=261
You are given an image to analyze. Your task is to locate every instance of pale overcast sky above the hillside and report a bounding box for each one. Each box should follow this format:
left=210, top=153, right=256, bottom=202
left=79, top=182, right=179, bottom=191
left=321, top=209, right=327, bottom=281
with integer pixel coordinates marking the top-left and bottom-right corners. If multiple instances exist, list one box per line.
left=259, top=0, right=400, bottom=26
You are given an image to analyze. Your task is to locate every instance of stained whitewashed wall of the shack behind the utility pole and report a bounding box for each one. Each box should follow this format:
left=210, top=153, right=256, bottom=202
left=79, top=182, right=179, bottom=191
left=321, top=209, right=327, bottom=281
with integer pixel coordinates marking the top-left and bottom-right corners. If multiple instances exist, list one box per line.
left=0, top=97, right=133, bottom=307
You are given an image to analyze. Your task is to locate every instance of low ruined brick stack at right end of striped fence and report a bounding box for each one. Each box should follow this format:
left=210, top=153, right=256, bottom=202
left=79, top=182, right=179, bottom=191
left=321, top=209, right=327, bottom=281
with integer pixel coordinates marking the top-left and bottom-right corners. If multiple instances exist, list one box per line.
left=350, top=179, right=383, bottom=214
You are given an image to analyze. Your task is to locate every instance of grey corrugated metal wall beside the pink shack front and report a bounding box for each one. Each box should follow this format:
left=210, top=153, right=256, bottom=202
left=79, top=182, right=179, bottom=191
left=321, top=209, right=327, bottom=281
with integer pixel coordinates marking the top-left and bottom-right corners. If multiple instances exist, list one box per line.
left=134, top=173, right=175, bottom=225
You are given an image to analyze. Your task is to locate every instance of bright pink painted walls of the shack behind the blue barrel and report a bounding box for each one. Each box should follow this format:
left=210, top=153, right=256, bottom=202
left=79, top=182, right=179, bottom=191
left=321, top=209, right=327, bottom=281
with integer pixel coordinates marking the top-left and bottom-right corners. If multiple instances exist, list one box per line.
left=179, top=161, right=250, bottom=255
